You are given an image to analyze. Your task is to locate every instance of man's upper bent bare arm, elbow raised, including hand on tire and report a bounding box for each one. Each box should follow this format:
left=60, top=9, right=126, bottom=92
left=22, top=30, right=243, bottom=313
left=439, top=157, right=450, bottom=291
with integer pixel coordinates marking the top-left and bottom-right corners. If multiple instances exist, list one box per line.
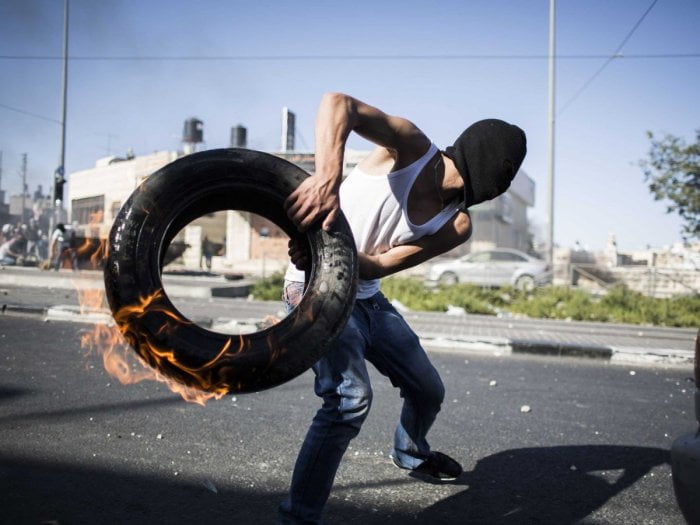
left=285, top=93, right=430, bottom=232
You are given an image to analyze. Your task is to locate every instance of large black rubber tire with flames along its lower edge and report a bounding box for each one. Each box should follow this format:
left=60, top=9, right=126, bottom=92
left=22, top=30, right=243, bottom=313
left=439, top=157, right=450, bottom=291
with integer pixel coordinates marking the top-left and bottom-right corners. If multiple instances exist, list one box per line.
left=104, top=149, right=358, bottom=394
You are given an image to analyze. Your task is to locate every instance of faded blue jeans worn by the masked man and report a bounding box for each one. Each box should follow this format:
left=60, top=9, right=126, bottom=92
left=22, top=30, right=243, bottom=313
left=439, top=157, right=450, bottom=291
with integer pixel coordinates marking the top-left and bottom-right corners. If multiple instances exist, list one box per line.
left=278, top=283, right=445, bottom=524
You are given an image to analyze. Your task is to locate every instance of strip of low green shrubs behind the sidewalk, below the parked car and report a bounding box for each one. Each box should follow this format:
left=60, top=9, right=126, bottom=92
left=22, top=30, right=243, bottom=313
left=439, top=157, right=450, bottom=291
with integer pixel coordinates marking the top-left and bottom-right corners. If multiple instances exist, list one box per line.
left=382, top=277, right=700, bottom=328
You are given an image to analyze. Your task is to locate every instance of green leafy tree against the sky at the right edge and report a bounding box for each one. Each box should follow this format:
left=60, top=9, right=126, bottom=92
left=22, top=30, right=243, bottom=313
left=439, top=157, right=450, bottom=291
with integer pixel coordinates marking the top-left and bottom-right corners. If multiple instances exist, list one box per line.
left=639, top=129, right=700, bottom=240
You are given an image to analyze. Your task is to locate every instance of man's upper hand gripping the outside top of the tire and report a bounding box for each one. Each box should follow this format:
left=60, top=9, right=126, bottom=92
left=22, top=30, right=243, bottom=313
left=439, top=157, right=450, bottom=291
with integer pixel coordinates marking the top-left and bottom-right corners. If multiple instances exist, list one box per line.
left=284, top=175, right=340, bottom=232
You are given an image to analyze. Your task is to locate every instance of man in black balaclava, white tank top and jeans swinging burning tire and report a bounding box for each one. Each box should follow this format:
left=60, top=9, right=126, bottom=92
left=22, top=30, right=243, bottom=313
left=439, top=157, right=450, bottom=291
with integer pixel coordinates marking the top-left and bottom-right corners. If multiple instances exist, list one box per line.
left=279, top=93, right=526, bottom=523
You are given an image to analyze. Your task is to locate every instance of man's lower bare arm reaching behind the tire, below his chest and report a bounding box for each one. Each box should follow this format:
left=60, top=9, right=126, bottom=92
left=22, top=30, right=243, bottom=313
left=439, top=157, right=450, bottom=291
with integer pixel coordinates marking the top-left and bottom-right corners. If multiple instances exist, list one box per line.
left=358, top=211, right=472, bottom=279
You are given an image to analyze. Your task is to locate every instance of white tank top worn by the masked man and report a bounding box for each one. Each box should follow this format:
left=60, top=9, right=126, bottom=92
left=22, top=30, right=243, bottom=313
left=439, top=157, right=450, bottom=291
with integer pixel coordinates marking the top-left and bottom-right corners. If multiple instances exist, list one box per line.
left=285, top=144, right=460, bottom=299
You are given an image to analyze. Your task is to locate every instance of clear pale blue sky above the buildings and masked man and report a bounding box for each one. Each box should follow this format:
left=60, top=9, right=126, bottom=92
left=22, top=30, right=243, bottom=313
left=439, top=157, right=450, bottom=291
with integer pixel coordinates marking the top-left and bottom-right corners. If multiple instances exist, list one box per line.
left=0, top=0, right=700, bottom=250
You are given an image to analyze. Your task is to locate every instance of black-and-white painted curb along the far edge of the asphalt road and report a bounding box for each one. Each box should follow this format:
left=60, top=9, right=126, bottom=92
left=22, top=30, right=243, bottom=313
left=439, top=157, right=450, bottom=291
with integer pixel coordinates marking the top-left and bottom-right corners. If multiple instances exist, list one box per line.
left=0, top=305, right=695, bottom=366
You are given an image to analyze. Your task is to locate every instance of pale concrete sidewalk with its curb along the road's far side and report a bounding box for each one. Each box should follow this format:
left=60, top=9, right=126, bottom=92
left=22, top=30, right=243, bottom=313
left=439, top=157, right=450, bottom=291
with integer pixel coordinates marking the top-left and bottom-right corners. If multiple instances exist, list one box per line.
left=0, top=268, right=697, bottom=366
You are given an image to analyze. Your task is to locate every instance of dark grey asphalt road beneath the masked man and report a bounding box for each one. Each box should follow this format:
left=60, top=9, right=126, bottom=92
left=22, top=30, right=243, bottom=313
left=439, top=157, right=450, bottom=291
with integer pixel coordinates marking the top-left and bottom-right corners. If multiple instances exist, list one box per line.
left=0, top=315, right=695, bottom=525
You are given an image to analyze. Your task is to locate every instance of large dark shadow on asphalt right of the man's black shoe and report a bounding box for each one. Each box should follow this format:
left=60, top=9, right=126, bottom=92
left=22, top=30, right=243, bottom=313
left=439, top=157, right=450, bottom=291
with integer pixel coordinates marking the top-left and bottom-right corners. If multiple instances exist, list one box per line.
left=418, top=445, right=670, bottom=525
